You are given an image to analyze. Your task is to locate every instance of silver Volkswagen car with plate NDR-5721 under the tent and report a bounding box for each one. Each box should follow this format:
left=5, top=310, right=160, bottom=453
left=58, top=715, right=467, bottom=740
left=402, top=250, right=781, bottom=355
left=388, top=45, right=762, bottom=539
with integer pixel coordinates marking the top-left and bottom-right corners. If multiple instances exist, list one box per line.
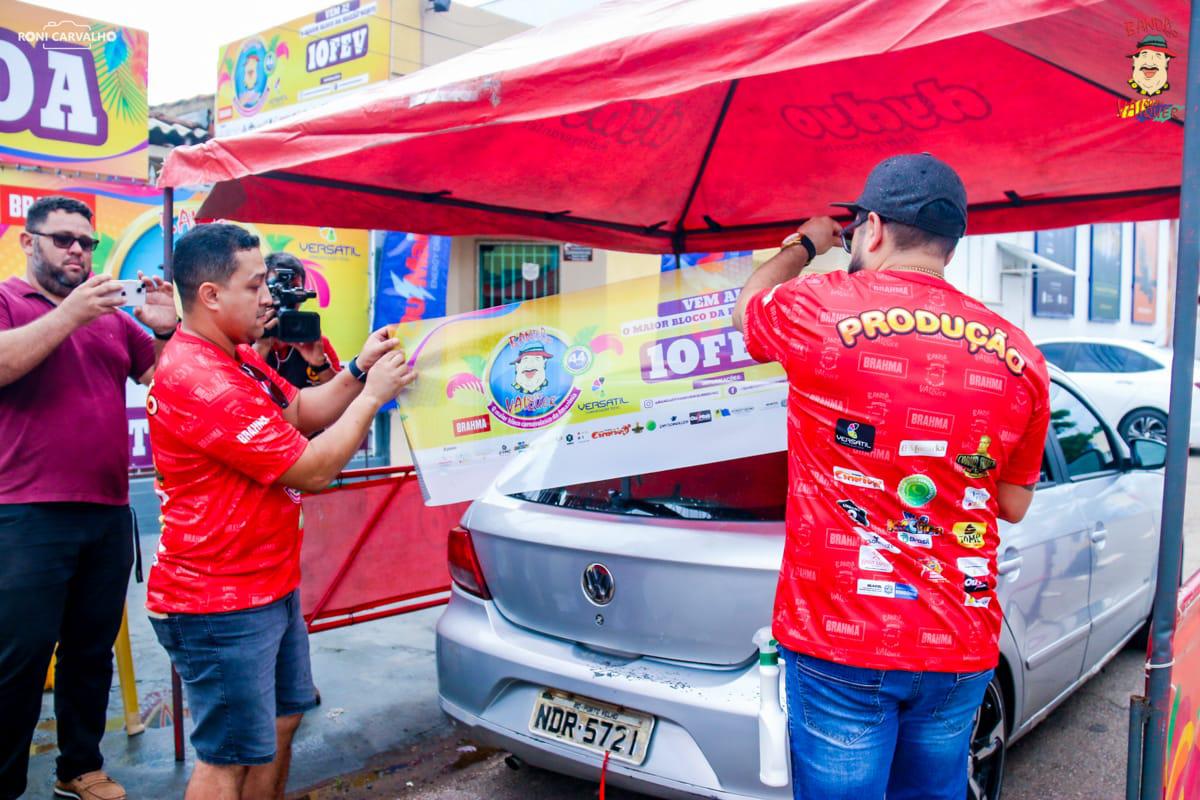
left=437, top=369, right=1165, bottom=799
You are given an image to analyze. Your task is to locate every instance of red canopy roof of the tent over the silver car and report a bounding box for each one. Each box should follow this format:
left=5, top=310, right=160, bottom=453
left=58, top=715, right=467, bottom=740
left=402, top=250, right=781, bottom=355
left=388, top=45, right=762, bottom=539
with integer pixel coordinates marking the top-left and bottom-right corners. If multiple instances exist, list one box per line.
left=161, top=0, right=1189, bottom=252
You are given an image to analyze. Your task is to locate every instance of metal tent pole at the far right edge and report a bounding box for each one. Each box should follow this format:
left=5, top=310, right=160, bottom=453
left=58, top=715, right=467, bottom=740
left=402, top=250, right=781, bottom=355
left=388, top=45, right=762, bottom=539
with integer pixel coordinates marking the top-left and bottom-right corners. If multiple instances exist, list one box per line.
left=1141, top=3, right=1200, bottom=800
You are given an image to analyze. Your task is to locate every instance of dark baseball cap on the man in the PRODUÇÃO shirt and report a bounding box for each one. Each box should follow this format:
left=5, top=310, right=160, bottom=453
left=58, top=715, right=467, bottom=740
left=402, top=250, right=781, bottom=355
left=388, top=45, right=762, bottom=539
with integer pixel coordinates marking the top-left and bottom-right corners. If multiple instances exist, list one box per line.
left=830, top=152, right=967, bottom=239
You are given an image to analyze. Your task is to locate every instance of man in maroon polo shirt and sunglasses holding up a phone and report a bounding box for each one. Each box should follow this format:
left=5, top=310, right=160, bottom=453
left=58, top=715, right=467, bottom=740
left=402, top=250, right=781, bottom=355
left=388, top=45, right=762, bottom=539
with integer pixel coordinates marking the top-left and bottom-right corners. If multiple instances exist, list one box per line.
left=0, top=197, right=178, bottom=800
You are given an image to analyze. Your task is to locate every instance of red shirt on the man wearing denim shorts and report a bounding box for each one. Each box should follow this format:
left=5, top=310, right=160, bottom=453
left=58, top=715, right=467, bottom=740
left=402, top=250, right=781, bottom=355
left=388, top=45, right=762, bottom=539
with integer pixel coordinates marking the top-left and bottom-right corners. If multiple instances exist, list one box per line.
left=146, top=330, right=308, bottom=614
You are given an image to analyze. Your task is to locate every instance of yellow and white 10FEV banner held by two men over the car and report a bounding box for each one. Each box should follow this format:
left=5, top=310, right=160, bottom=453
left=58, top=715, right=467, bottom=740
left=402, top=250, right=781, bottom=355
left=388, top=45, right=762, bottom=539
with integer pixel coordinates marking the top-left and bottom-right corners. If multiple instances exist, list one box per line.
left=388, top=257, right=786, bottom=505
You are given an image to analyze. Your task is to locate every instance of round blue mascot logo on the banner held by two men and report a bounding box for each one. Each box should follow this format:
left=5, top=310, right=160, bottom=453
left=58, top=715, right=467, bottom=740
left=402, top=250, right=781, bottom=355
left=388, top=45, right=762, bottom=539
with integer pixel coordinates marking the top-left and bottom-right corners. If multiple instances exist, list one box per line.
left=486, top=327, right=580, bottom=429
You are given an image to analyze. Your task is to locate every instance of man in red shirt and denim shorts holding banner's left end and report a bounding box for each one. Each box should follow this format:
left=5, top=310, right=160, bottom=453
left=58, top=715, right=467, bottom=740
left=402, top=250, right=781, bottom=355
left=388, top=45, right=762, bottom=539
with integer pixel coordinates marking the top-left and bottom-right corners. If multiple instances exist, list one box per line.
left=146, top=224, right=415, bottom=800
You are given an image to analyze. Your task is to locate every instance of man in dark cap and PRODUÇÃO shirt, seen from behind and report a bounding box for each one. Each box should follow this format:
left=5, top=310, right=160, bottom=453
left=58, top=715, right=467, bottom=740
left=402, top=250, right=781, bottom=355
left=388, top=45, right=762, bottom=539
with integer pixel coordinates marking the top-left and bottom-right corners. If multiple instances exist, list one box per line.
left=734, top=154, right=1049, bottom=800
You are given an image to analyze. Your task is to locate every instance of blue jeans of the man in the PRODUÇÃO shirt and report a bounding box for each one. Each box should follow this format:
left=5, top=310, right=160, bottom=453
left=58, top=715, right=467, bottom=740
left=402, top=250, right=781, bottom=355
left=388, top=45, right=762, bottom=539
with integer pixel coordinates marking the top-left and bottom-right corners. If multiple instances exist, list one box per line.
left=780, top=648, right=992, bottom=800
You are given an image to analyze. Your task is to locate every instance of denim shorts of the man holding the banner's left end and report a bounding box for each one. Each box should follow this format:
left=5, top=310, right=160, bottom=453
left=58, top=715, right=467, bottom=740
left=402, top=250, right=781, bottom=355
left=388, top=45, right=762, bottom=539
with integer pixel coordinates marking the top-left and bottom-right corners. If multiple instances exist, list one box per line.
left=150, top=590, right=317, bottom=765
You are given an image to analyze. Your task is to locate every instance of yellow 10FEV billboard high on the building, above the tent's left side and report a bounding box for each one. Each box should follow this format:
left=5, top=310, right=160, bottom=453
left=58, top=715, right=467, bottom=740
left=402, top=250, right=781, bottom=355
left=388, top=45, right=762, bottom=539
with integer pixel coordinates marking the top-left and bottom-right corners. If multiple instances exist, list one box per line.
left=216, top=0, right=391, bottom=137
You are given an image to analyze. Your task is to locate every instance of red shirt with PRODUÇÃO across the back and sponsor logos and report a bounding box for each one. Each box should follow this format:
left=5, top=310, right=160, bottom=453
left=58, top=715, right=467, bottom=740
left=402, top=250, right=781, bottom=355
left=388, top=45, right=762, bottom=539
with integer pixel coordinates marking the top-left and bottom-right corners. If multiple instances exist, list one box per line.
left=744, top=270, right=1050, bottom=672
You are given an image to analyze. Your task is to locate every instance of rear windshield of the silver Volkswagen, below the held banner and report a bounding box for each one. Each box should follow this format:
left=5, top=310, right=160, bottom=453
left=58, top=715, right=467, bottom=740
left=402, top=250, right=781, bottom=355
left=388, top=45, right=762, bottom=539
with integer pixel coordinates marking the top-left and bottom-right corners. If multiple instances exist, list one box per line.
left=512, top=452, right=787, bottom=522
